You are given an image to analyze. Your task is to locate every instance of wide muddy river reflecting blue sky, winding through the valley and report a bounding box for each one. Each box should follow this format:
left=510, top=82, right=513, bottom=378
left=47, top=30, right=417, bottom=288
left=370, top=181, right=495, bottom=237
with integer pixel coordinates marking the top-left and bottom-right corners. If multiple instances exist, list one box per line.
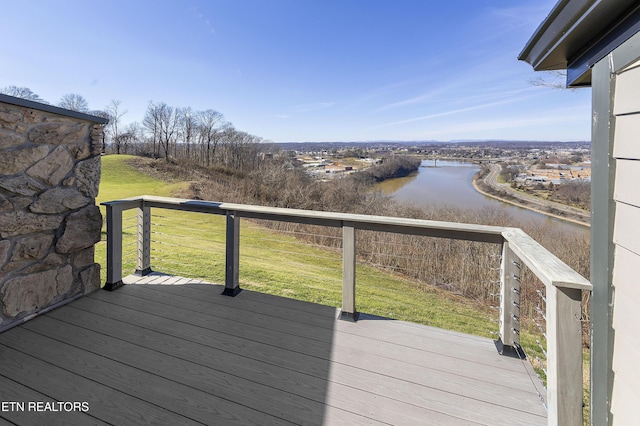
left=377, top=160, right=589, bottom=232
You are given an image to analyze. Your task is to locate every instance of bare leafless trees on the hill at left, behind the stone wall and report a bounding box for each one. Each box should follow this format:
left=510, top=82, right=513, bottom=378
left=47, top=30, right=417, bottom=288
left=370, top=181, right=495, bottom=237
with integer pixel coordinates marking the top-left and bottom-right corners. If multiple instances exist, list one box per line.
left=0, top=86, right=274, bottom=171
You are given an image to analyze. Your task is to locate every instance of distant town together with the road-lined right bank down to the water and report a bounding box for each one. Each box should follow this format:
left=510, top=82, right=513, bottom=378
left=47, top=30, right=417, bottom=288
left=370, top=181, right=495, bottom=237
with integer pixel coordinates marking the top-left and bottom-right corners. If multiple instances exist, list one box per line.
left=277, top=141, right=591, bottom=225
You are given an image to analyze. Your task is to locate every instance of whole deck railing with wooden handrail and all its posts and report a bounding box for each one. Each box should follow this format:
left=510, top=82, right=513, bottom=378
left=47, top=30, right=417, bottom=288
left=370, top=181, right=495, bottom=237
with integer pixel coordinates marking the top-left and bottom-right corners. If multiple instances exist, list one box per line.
left=103, top=195, right=592, bottom=425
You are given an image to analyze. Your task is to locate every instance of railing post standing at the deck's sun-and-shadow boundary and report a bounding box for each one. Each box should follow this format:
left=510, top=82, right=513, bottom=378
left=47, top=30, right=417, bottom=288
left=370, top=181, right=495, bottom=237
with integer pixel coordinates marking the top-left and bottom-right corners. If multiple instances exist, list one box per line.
left=340, top=222, right=358, bottom=321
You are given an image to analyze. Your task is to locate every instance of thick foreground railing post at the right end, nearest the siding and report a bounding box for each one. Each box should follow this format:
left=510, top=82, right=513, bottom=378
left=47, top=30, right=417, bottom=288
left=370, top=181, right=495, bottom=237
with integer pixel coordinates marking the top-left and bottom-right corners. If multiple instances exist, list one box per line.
left=546, top=286, right=583, bottom=425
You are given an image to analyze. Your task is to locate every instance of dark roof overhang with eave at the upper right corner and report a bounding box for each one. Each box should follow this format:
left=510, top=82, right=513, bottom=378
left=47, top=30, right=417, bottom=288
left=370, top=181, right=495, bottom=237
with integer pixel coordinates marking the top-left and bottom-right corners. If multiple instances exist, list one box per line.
left=518, top=0, right=640, bottom=87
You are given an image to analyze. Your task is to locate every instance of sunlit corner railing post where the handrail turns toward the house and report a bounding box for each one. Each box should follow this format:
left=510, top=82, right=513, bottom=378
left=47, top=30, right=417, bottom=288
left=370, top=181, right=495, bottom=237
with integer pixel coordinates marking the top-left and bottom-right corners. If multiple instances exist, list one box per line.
left=496, top=241, right=524, bottom=358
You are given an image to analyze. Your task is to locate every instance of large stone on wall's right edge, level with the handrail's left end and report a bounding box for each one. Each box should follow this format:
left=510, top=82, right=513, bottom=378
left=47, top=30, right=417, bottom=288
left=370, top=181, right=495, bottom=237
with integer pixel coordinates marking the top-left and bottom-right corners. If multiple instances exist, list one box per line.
left=56, top=205, right=102, bottom=253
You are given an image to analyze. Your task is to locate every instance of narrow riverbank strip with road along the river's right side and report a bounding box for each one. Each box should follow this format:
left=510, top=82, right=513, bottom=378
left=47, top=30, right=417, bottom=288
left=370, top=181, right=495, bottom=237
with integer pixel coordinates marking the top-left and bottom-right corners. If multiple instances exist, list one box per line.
left=471, top=168, right=591, bottom=228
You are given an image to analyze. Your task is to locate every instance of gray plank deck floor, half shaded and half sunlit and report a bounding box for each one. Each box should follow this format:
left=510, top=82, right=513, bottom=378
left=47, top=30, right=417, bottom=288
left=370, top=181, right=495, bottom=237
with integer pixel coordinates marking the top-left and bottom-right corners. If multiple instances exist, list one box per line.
left=0, top=275, right=547, bottom=425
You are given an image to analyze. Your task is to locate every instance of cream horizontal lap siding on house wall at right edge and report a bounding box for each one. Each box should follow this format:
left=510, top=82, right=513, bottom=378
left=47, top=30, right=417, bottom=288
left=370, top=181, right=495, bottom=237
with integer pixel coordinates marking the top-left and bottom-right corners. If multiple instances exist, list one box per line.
left=611, top=58, right=640, bottom=424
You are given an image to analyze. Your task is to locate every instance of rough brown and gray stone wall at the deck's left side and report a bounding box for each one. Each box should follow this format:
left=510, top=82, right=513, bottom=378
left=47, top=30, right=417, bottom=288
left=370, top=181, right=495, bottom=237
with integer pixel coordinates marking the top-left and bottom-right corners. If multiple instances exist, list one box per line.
left=0, top=98, right=103, bottom=331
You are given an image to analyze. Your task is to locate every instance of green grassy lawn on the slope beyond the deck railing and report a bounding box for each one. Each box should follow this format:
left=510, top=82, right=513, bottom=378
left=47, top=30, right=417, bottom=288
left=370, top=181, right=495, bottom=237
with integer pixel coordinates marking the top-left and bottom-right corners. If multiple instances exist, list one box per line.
left=96, top=155, right=497, bottom=337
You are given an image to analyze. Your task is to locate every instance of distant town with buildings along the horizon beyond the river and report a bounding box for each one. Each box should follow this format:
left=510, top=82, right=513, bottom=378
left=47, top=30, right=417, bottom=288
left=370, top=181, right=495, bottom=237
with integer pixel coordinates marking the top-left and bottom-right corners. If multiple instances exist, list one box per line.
left=277, top=141, right=591, bottom=187
